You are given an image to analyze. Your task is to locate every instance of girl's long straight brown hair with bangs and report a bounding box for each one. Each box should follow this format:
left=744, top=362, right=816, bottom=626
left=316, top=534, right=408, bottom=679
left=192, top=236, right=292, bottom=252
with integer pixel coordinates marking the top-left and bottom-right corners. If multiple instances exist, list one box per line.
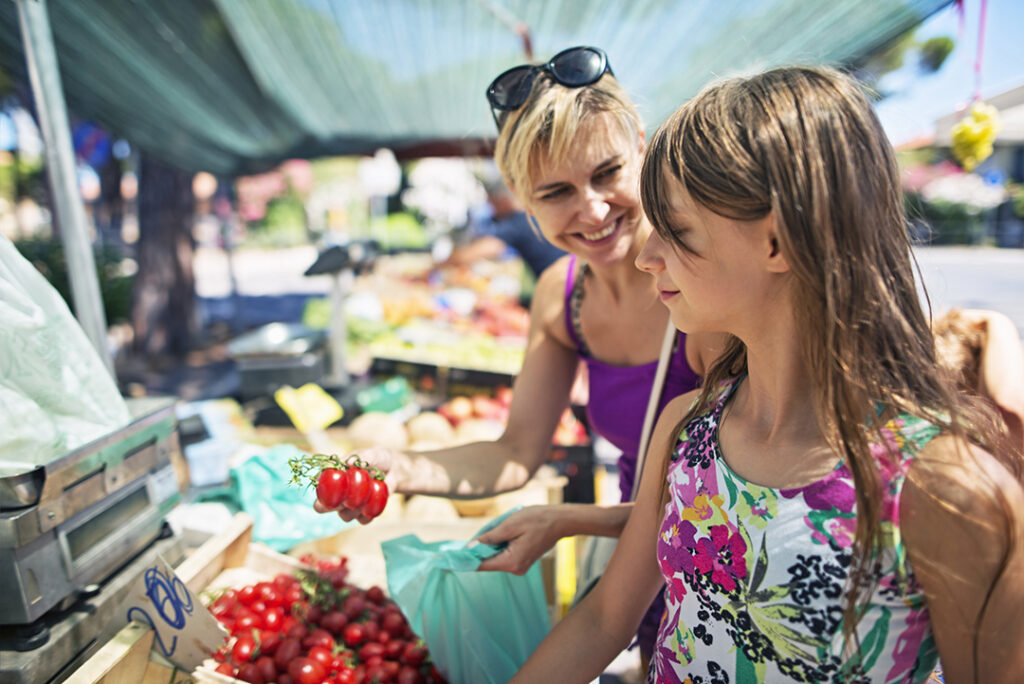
left=641, top=67, right=1022, bottom=675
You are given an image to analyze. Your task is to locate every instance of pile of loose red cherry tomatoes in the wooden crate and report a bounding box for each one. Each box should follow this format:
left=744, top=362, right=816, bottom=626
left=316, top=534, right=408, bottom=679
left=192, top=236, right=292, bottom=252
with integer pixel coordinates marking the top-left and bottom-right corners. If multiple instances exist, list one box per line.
left=210, top=556, right=444, bottom=684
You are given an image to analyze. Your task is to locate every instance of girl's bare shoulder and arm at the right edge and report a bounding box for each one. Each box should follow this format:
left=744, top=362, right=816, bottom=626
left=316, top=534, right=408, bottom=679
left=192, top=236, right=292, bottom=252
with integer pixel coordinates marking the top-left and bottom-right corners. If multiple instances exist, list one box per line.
left=900, top=436, right=1024, bottom=684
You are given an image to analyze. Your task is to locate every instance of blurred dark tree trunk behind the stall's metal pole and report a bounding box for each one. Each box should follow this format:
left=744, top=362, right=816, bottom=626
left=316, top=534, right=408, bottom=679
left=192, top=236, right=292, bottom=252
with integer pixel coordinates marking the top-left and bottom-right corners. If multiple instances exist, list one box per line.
left=131, top=154, right=197, bottom=357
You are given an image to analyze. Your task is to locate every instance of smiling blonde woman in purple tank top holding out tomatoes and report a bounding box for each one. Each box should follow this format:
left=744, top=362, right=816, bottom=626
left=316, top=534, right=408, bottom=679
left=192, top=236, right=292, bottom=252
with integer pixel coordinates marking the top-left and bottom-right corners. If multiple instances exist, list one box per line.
left=319, top=46, right=721, bottom=655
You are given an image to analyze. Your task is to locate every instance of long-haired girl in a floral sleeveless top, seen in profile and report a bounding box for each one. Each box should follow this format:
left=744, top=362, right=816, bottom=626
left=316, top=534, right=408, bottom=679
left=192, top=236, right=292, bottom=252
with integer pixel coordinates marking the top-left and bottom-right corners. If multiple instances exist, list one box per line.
left=514, top=68, right=1024, bottom=684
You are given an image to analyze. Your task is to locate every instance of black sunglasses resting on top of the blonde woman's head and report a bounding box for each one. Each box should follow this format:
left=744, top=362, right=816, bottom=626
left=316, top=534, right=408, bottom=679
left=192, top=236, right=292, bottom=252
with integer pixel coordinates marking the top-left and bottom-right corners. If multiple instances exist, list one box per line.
left=487, top=45, right=614, bottom=131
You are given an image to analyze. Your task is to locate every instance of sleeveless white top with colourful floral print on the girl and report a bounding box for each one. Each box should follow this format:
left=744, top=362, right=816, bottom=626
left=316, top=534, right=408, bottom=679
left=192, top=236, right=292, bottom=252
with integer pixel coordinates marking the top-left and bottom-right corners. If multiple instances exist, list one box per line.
left=647, top=380, right=939, bottom=684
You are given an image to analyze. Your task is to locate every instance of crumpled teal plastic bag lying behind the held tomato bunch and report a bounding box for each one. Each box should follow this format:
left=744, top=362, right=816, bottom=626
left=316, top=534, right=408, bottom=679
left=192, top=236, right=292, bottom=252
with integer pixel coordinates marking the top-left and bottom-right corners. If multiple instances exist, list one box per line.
left=230, top=444, right=355, bottom=552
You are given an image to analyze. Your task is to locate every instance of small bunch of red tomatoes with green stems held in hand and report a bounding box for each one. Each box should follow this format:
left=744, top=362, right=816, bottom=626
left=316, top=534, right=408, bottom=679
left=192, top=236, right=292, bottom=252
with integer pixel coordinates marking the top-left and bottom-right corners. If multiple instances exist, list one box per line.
left=288, top=454, right=388, bottom=519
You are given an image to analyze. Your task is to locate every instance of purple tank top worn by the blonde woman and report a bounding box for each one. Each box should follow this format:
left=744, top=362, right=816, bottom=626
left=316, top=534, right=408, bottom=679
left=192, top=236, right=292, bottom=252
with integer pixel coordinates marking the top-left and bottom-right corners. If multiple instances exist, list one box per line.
left=565, top=255, right=700, bottom=502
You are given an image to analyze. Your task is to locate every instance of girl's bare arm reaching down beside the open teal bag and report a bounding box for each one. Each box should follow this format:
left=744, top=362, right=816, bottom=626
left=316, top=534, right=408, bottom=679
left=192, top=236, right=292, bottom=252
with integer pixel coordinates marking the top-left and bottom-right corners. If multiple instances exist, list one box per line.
left=512, top=392, right=696, bottom=684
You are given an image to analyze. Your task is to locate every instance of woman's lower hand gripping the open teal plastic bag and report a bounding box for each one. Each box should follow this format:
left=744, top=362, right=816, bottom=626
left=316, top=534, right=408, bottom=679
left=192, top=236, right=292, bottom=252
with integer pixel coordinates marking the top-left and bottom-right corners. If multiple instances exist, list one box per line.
left=474, top=506, right=562, bottom=574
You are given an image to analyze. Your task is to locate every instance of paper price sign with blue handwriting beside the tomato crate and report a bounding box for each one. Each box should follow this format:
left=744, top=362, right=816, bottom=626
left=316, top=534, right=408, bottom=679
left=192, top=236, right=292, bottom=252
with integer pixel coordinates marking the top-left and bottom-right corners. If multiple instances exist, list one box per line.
left=121, top=556, right=227, bottom=672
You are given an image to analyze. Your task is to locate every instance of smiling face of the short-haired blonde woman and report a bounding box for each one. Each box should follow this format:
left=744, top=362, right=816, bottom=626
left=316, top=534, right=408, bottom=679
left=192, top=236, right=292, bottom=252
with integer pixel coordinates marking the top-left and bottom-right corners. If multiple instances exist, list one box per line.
left=522, top=114, right=643, bottom=265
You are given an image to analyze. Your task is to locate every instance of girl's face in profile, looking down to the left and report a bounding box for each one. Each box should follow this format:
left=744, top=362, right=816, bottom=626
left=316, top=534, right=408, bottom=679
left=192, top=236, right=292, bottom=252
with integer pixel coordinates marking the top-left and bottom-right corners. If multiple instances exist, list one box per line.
left=636, top=174, right=779, bottom=338
